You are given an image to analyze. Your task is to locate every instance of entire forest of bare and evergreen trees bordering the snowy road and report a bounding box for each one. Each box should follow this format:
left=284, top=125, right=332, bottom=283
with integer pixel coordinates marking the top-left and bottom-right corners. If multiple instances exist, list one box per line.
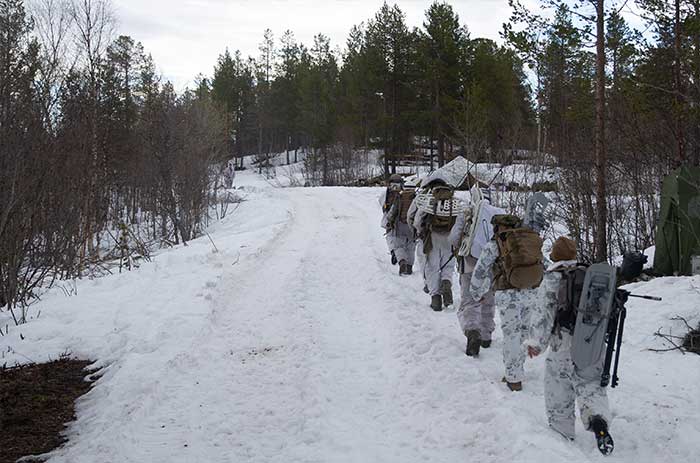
left=0, top=0, right=700, bottom=321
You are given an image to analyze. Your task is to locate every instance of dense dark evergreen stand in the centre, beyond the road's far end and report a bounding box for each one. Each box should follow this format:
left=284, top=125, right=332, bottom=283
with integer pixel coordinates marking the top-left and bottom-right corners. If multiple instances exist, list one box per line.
left=200, top=2, right=535, bottom=185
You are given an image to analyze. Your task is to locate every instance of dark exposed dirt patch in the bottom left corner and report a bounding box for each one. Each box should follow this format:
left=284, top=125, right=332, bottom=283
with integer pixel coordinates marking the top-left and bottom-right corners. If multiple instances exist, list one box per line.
left=0, top=359, right=92, bottom=463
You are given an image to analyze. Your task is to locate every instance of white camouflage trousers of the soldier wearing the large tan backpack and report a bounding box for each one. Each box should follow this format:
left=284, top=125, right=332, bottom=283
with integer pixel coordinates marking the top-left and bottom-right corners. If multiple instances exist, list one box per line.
left=495, top=289, right=537, bottom=383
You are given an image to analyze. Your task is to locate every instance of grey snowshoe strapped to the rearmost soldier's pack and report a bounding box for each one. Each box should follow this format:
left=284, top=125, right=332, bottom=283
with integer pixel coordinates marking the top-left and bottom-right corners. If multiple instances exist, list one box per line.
left=571, top=263, right=617, bottom=381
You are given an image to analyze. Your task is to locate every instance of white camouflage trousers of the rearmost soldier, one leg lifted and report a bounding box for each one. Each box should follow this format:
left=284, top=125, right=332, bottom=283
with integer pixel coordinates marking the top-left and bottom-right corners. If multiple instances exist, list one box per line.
left=544, top=332, right=610, bottom=439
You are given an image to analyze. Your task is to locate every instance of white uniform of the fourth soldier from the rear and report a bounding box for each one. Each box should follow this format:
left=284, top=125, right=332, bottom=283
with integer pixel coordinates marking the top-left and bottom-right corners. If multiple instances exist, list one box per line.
left=413, top=210, right=455, bottom=296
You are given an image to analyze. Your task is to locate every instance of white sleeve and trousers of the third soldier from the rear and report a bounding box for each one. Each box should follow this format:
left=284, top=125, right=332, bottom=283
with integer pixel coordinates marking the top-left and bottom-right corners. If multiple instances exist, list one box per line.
left=450, top=208, right=496, bottom=340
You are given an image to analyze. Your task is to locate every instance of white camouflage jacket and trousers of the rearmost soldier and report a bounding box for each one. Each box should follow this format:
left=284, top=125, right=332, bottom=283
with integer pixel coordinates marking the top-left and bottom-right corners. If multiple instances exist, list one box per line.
left=524, top=261, right=610, bottom=440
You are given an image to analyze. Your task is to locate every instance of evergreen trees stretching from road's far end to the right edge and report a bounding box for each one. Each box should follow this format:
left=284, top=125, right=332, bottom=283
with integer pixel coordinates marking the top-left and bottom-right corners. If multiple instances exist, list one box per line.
left=200, top=0, right=700, bottom=261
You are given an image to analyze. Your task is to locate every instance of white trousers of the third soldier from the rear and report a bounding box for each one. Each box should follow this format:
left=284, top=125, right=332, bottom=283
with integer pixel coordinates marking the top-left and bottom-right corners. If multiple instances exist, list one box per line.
left=457, top=256, right=496, bottom=340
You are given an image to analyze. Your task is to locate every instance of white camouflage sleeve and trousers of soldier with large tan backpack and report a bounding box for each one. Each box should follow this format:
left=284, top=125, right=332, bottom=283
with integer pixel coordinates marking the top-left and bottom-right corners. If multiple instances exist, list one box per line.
left=469, top=240, right=537, bottom=383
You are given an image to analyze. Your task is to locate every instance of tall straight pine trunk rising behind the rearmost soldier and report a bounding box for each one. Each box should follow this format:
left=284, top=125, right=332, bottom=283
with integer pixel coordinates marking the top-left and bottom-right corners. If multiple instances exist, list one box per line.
left=595, top=0, right=608, bottom=262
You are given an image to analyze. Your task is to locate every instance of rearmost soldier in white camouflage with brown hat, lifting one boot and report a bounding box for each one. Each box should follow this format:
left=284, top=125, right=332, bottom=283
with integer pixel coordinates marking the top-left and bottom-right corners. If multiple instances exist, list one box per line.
left=524, top=237, right=613, bottom=454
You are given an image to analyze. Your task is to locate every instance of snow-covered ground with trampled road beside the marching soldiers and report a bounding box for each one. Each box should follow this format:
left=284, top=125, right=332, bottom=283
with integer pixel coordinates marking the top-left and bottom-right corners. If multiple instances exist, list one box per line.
left=0, top=171, right=700, bottom=463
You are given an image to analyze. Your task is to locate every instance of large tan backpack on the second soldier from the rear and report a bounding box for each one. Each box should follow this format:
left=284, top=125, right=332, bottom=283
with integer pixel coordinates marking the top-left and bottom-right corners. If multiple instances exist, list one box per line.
left=491, top=214, right=544, bottom=290
